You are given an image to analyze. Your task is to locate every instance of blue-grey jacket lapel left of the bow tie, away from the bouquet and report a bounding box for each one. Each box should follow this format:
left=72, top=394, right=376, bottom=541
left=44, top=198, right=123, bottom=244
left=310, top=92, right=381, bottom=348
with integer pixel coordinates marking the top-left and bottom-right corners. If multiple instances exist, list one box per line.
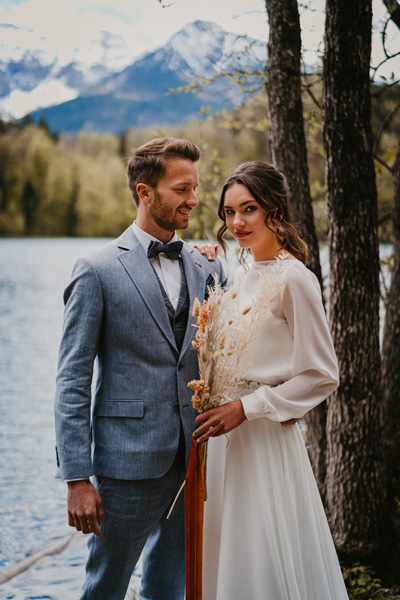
left=118, top=227, right=178, bottom=352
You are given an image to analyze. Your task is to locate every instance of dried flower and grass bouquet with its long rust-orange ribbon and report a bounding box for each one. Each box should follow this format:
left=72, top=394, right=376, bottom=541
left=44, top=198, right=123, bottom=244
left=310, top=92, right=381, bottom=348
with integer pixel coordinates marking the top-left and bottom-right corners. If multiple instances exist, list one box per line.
left=184, top=257, right=284, bottom=600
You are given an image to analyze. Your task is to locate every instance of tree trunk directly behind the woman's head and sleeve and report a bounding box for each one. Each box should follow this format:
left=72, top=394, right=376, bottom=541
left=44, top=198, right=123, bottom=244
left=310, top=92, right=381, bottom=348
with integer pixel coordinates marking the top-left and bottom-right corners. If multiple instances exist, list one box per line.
left=265, top=0, right=326, bottom=499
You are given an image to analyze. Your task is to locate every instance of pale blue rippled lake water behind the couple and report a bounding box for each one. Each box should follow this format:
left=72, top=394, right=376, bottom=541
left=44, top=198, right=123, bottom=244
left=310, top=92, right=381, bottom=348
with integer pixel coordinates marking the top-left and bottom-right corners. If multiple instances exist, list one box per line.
left=0, top=239, right=390, bottom=600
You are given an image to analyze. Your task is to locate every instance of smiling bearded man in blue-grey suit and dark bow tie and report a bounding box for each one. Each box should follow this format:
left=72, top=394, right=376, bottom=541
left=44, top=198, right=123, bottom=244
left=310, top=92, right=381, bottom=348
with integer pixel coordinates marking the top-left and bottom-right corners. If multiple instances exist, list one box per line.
left=55, top=138, right=223, bottom=600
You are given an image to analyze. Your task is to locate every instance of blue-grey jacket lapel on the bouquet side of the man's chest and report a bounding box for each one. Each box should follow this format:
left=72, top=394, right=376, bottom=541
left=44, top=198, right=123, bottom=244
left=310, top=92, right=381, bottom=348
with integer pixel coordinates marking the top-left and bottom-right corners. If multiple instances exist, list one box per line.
left=181, top=243, right=206, bottom=356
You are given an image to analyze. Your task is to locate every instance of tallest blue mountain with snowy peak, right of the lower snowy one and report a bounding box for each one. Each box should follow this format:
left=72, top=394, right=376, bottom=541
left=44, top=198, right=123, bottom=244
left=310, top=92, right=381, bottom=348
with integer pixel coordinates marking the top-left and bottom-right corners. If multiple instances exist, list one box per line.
left=0, top=21, right=266, bottom=134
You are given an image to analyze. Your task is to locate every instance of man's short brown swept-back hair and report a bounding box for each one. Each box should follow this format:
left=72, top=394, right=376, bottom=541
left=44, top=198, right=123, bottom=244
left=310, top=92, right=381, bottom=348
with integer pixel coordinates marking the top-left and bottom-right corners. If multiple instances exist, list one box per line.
left=127, top=138, right=201, bottom=206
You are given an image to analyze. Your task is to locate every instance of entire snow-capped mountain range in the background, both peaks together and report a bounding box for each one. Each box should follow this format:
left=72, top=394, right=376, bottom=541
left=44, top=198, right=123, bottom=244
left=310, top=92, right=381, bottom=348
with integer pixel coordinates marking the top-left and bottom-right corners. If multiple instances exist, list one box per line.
left=0, top=21, right=266, bottom=132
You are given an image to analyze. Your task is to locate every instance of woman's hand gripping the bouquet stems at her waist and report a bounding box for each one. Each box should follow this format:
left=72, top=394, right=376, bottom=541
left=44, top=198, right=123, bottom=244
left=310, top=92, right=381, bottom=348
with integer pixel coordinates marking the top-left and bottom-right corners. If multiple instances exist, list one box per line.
left=193, top=400, right=246, bottom=442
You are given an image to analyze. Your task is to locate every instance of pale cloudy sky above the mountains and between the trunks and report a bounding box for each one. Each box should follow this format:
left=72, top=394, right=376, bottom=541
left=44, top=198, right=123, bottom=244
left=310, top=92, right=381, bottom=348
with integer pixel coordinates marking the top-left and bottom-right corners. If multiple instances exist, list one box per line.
left=0, top=0, right=400, bottom=78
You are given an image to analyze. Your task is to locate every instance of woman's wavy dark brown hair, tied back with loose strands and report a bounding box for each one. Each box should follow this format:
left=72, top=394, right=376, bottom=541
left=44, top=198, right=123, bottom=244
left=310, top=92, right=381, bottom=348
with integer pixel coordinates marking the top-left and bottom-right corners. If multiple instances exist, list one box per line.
left=217, top=160, right=308, bottom=264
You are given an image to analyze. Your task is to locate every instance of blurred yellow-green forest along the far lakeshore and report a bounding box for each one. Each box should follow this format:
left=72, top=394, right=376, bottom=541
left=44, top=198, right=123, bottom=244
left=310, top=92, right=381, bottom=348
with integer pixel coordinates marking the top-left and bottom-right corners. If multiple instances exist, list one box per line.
left=0, top=81, right=400, bottom=241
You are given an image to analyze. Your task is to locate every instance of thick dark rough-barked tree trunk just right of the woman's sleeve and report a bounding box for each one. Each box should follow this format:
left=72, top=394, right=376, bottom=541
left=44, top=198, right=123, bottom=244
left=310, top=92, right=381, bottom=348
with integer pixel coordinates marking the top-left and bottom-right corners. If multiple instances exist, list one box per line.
left=323, top=0, right=383, bottom=562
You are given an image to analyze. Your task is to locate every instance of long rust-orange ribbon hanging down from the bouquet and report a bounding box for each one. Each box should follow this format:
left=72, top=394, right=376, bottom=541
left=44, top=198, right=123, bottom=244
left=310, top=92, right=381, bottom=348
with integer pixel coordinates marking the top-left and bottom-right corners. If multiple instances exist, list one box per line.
left=185, top=438, right=204, bottom=600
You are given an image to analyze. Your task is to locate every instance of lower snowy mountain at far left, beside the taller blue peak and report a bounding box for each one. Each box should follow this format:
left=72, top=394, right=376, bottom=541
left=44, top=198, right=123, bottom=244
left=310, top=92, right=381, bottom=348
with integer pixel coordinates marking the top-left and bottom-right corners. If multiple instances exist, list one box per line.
left=0, top=23, right=138, bottom=118
